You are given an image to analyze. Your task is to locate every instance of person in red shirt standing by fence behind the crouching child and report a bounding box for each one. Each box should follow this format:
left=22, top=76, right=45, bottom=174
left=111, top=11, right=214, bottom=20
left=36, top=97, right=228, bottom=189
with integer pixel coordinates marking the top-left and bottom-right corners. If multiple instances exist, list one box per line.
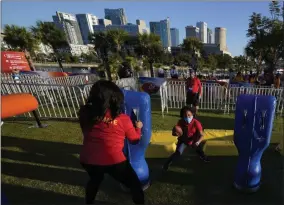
left=186, top=71, right=202, bottom=114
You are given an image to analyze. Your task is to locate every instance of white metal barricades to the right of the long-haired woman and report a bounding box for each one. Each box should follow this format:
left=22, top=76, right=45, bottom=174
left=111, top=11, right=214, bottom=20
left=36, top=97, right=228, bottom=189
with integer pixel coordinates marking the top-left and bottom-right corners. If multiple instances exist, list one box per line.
left=161, top=81, right=284, bottom=114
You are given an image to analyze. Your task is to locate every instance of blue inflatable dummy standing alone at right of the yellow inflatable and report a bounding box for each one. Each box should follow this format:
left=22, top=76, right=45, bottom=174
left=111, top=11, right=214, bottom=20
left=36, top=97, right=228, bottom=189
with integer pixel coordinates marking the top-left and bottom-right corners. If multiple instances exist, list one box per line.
left=234, top=95, right=276, bottom=192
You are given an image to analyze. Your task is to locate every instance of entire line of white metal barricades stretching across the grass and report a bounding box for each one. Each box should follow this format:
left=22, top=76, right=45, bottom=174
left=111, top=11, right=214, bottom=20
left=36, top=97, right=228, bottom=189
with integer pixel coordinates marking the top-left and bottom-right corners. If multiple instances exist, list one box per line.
left=1, top=81, right=284, bottom=119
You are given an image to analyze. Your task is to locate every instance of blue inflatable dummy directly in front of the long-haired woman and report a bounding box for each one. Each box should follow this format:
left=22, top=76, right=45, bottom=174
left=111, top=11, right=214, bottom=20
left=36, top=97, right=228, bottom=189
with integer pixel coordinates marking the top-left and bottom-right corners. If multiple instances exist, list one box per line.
left=123, top=90, right=152, bottom=189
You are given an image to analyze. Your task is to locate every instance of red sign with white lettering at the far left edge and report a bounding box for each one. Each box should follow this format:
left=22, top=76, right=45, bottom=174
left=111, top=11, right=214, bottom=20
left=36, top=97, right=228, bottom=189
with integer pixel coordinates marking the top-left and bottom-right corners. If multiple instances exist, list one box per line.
left=1, top=51, right=31, bottom=73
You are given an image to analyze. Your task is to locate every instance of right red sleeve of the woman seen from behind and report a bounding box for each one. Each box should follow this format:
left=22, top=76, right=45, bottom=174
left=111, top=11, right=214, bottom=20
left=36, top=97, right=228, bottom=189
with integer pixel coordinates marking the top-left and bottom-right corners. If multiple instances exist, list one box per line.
left=122, top=115, right=141, bottom=142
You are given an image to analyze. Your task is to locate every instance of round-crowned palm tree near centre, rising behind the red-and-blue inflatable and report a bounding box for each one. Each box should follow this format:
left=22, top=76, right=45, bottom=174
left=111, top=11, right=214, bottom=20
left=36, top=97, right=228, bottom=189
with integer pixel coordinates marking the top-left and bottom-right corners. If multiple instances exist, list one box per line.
left=135, top=33, right=164, bottom=77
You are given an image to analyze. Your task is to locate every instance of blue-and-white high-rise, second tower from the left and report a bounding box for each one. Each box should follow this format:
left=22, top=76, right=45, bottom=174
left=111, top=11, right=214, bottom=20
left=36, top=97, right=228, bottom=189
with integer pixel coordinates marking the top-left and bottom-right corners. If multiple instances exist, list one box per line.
left=76, top=14, right=99, bottom=44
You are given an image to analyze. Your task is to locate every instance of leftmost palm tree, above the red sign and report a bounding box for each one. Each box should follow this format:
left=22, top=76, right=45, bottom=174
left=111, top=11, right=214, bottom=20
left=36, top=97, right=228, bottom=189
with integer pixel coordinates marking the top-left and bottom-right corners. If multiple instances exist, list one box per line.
left=3, top=25, right=39, bottom=71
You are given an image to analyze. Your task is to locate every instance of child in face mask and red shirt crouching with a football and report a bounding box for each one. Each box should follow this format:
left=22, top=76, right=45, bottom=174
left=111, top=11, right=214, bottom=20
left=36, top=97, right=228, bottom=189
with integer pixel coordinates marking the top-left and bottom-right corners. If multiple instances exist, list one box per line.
left=163, top=106, right=209, bottom=170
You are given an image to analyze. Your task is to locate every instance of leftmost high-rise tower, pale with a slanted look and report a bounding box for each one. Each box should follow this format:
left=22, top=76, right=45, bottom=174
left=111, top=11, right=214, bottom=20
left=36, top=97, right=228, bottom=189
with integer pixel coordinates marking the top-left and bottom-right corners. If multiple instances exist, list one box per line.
left=52, top=11, right=83, bottom=45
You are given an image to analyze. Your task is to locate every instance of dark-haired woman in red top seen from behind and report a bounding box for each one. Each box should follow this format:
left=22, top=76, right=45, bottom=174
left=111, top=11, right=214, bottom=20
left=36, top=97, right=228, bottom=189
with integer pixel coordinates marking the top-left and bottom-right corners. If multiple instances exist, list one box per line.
left=79, top=80, right=144, bottom=204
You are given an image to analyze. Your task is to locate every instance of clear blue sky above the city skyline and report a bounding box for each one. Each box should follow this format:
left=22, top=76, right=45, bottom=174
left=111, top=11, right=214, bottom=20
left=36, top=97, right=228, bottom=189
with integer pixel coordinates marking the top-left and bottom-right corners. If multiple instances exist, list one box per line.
left=2, top=1, right=269, bottom=56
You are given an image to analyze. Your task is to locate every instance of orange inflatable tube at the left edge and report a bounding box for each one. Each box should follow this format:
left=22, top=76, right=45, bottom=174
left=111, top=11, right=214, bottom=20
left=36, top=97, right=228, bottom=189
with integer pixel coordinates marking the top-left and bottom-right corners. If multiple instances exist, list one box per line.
left=1, top=93, right=38, bottom=119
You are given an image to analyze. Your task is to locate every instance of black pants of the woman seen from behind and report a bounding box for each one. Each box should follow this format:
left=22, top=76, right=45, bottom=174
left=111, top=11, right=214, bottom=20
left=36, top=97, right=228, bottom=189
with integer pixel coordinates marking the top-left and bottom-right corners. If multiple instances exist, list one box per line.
left=82, top=161, right=144, bottom=204
